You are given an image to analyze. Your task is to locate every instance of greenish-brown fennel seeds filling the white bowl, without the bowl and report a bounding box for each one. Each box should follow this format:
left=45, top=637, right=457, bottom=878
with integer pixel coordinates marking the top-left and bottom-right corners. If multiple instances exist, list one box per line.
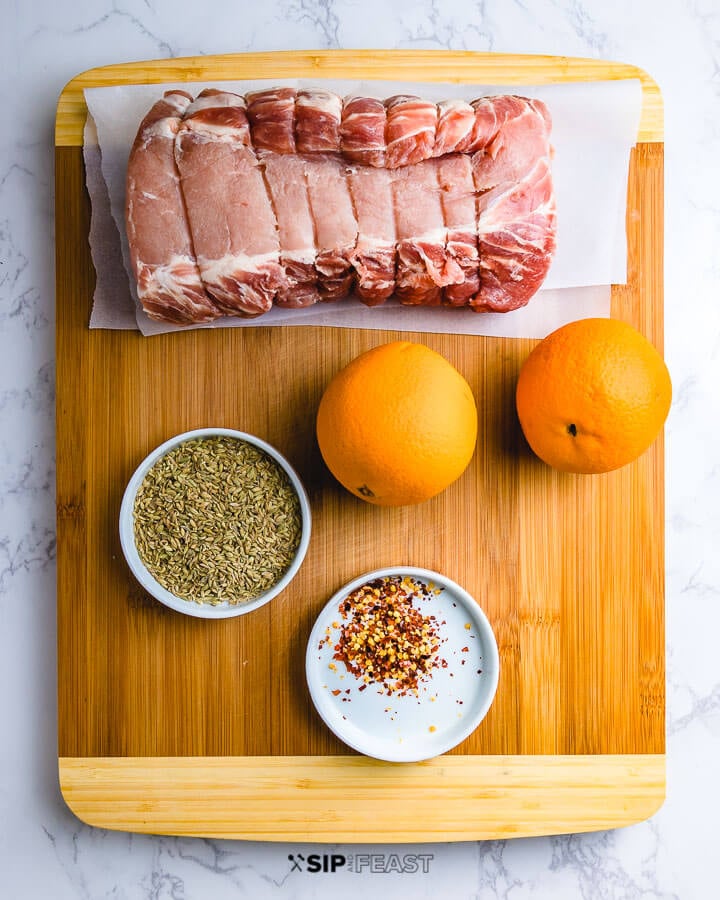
left=133, top=436, right=302, bottom=606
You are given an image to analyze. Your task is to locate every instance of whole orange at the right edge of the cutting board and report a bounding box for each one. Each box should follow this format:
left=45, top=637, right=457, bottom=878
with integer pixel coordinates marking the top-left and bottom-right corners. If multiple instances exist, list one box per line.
left=516, top=319, right=672, bottom=474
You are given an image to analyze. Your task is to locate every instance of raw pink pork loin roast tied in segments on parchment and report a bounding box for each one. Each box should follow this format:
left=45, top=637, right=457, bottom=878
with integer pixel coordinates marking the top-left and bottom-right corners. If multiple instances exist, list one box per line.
left=126, top=87, right=556, bottom=325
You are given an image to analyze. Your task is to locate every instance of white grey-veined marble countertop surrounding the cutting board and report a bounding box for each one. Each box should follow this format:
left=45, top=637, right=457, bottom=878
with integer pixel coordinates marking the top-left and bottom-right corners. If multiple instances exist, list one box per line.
left=0, top=0, right=720, bottom=900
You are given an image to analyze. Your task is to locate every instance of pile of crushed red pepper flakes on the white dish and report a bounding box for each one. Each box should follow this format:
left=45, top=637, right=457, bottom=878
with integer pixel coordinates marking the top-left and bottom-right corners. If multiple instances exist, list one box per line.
left=333, top=576, right=447, bottom=696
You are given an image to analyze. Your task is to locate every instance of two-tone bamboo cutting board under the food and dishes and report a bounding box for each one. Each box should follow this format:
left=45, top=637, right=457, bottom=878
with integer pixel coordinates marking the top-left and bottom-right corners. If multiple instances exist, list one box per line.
left=56, top=51, right=665, bottom=842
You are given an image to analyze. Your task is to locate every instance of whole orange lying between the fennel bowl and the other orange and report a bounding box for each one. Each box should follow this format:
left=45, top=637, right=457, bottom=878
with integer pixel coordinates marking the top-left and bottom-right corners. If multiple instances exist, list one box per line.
left=317, top=341, right=477, bottom=506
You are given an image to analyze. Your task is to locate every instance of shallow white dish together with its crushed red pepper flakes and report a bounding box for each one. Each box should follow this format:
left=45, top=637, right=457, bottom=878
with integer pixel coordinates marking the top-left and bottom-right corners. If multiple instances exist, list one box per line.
left=305, top=567, right=499, bottom=762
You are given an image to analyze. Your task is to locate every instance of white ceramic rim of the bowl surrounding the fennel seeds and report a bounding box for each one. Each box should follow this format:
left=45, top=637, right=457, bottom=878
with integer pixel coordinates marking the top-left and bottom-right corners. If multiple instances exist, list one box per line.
left=120, top=428, right=311, bottom=619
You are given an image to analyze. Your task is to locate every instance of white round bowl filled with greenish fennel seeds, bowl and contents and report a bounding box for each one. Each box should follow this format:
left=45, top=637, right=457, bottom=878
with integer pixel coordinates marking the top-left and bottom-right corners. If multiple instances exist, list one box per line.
left=120, top=428, right=310, bottom=619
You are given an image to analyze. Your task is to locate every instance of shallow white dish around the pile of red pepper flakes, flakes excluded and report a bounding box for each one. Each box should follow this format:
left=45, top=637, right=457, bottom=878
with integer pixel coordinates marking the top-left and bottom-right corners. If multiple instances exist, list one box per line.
left=305, top=566, right=500, bottom=762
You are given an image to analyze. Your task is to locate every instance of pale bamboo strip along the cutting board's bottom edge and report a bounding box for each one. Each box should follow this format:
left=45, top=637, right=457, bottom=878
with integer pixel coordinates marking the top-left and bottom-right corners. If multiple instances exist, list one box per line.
left=60, top=754, right=665, bottom=843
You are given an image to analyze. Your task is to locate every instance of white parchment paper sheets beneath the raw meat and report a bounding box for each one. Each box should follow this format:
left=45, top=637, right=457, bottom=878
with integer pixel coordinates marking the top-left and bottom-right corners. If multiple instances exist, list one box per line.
left=84, top=79, right=642, bottom=337
